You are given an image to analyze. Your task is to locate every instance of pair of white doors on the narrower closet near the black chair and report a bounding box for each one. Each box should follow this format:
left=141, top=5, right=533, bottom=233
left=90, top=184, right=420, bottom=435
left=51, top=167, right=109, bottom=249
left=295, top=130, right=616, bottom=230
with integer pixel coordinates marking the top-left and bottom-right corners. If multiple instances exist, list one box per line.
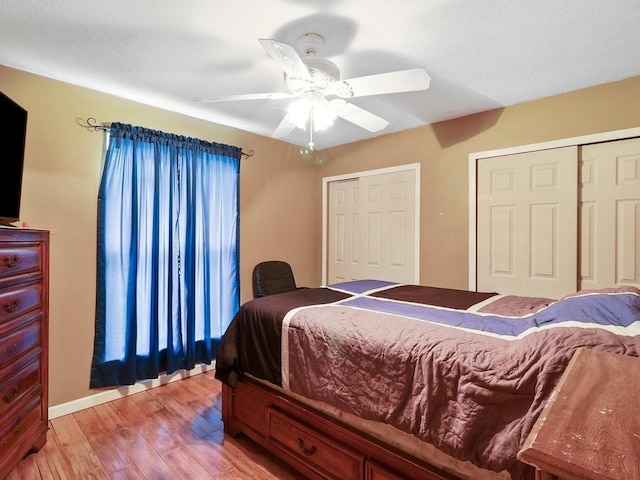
left=327, top=169, right=418, bottom=284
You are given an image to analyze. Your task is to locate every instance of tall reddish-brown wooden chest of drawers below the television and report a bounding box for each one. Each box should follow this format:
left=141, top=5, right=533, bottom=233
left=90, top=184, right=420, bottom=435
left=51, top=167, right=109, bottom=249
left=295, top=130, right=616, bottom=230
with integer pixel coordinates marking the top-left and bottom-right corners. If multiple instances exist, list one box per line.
left=0, top=227, right=49, bottom=479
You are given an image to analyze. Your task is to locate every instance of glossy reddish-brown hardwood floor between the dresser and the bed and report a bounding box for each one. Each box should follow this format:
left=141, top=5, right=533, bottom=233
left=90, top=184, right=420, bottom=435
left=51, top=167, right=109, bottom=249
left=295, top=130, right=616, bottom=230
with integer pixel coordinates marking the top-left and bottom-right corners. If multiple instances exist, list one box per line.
left=6, top=371, right=301, bottom=480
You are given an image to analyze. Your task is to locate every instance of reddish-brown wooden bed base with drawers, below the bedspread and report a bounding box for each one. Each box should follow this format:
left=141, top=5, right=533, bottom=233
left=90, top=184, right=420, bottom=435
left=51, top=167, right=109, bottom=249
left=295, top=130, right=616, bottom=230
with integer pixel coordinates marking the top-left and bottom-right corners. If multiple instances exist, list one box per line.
left=222, top=376, right=470, bottom=480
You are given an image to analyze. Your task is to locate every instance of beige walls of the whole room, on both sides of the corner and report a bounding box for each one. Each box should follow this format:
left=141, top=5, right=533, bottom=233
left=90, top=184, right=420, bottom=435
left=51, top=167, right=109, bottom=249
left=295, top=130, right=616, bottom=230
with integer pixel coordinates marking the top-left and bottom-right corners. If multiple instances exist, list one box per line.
left=0, top=66, right=640, bottom=405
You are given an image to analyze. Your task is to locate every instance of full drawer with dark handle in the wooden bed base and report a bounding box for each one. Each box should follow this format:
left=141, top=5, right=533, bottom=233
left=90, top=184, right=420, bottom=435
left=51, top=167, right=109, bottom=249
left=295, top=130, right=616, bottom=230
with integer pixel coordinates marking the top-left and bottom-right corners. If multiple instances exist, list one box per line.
left=267, top=408, right=364, bottom=480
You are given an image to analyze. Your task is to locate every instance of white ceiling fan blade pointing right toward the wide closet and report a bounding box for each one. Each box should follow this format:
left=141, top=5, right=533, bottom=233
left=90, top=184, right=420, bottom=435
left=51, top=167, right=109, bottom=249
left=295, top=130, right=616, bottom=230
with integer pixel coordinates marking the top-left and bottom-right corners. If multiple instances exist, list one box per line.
left=327, top=68, right=431, bottom=98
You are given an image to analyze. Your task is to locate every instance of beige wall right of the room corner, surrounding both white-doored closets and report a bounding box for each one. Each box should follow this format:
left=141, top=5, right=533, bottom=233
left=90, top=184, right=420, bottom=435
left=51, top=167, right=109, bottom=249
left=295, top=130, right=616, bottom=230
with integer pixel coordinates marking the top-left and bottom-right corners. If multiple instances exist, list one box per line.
left=316, top=77, right=640, bottom=289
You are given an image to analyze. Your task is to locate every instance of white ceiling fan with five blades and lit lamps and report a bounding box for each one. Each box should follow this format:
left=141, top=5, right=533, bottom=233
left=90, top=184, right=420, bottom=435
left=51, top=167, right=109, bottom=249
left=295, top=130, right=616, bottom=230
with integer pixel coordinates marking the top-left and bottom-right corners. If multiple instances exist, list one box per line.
left=200, top=33, right=431, bottom=150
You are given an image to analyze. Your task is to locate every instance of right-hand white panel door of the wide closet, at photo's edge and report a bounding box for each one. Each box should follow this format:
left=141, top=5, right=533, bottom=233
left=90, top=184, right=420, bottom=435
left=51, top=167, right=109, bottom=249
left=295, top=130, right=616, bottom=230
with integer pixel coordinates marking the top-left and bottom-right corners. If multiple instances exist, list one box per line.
left=580, top=138, right=640, bottom=289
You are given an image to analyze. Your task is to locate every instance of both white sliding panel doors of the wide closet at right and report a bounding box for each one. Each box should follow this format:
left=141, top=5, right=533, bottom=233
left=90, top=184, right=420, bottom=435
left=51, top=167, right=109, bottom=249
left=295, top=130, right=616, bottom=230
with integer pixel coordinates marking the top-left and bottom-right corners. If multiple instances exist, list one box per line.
left=477, top=138, right=640, bottom=298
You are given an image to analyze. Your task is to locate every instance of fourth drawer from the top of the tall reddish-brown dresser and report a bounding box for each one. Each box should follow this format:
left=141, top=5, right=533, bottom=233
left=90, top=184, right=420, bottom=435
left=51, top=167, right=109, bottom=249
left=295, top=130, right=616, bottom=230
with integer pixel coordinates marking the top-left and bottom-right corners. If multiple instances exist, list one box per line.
left=0, top=350, right=40, bottom=418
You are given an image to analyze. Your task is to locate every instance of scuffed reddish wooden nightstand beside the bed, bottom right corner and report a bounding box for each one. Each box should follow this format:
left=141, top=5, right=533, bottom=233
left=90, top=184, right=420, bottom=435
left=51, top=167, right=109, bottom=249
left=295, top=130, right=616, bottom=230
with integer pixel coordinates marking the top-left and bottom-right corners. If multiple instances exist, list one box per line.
left=518, top=348, right=640, bottom=480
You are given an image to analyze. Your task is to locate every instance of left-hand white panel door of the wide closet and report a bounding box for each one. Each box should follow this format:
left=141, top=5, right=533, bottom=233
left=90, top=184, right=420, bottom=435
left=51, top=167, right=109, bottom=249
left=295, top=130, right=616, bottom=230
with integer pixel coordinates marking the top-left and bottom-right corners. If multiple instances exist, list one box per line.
left=477, top=146, right=578, bottom=298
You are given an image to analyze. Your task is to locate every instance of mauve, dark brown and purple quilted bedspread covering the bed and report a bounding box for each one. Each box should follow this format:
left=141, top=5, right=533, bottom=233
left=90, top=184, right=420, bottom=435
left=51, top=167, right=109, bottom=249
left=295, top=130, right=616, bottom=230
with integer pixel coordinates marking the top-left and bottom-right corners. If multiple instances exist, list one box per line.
left=216, top=281, right=640, bottom=479
